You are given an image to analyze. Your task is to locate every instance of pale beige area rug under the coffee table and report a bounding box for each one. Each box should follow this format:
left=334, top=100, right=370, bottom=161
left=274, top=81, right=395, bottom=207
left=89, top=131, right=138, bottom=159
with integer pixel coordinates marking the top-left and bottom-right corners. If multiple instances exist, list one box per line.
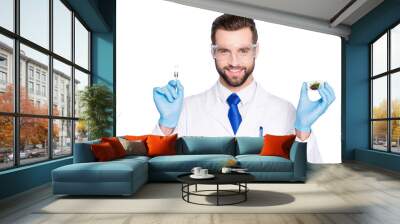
left=35, top=183, right=360, bottom=214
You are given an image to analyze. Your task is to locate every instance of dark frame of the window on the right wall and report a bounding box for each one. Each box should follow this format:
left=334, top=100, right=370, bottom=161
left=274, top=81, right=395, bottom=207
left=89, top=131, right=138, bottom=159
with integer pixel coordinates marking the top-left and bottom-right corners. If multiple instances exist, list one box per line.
left=368, top=21, right=400, bottom=155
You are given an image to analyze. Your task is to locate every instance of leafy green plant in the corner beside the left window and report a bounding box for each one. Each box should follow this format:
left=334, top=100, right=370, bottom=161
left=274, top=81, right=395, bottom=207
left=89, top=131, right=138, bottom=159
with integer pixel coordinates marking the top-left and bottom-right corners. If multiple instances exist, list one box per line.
left=79, top=84, right=114, bottom=140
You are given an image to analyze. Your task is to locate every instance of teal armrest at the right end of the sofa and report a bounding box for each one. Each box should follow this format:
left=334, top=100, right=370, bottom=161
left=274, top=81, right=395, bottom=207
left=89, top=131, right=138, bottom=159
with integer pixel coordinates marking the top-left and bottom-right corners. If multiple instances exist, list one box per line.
left=290, top=141, right=307, bottom=181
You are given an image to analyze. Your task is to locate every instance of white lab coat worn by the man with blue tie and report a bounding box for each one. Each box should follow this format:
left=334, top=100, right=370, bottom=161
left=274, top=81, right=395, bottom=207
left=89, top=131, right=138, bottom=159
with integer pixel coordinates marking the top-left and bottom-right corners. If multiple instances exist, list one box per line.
left=153, top=81, right=318, bottom=159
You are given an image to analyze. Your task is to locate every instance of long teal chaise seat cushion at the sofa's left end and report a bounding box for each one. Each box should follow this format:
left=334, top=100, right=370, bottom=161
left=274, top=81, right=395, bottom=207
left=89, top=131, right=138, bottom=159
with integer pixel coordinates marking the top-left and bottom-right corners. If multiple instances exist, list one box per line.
left=52, top=159, right=147, bottom=182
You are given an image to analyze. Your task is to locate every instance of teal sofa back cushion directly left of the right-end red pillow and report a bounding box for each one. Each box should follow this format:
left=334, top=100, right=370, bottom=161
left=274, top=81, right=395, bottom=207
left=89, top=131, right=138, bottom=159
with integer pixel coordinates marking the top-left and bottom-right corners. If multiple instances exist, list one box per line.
left=236, top=137, right=264, bottom=155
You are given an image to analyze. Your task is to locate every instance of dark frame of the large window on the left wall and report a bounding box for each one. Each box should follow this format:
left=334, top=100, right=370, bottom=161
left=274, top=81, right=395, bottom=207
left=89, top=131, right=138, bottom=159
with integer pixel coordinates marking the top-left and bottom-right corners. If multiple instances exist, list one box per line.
left=0, top=0, right=93, bottom=172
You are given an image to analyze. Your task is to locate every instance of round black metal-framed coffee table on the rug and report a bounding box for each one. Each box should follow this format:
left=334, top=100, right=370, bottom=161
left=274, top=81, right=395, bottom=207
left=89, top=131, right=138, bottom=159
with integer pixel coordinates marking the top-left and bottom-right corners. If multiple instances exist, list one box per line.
left=177, top=173, right=255, bottom=206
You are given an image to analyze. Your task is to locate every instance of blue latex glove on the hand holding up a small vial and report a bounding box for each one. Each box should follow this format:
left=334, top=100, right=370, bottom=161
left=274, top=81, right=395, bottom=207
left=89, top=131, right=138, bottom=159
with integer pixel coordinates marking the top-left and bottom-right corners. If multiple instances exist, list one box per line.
left=153, top=80, right=183, bottom=128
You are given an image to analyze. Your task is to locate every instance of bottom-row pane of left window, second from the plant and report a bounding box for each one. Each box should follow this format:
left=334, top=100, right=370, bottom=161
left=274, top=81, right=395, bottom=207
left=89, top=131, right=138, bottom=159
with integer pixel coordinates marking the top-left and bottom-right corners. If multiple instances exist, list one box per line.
left=53, top=120, right=72, bottom=157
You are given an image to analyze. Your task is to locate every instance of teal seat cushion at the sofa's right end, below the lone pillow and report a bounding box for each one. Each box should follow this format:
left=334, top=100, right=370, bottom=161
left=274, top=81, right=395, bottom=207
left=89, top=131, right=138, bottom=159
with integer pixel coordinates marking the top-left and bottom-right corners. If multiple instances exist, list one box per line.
left=236, top=155, right=293, bottom=172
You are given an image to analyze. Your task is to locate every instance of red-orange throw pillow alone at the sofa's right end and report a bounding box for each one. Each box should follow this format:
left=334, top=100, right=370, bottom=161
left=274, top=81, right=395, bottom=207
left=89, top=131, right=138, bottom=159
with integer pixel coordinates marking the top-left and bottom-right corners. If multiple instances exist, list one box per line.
left=260, top=134, right=296, bottom=159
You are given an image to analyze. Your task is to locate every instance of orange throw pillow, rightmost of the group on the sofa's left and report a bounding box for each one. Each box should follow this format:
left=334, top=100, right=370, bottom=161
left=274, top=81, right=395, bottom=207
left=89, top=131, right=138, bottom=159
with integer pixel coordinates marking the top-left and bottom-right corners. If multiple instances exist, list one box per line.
left=146, top=134, right=178, bottom=156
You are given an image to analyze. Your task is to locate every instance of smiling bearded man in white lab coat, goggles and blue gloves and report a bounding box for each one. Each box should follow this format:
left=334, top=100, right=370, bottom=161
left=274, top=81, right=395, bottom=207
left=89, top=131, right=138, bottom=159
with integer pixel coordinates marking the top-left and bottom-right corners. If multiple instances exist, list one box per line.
left=153, top=14, right=335, bottom=147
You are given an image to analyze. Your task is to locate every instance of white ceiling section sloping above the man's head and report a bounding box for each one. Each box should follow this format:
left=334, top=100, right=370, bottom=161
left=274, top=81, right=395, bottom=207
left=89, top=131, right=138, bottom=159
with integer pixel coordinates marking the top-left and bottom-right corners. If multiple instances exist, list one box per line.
left=168, top=0, right=383, bottom=38
